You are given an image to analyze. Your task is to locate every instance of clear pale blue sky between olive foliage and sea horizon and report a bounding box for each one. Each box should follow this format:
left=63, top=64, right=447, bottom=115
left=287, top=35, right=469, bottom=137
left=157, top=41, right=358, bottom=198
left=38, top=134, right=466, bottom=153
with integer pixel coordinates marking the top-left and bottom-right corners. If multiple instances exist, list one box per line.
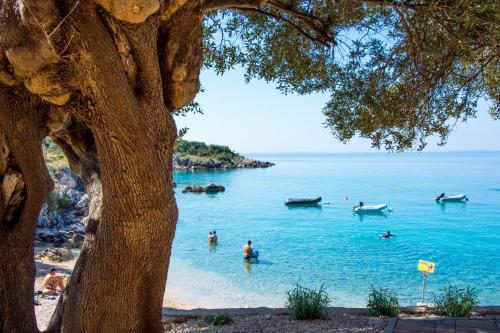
left=176, top=70, right=500, bottom=153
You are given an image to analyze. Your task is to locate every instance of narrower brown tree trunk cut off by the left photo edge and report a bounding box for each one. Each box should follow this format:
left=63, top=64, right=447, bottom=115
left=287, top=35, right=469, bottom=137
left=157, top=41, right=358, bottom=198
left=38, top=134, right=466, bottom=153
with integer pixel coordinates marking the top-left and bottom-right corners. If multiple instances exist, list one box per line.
left=0, top=87, right=52, bottom=332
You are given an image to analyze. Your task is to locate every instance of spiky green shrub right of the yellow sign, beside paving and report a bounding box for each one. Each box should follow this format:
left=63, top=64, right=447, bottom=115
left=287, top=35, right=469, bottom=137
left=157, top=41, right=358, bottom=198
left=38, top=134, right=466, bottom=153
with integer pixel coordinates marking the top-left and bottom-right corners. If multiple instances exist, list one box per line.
left=434, top=286, right=479, bottom=317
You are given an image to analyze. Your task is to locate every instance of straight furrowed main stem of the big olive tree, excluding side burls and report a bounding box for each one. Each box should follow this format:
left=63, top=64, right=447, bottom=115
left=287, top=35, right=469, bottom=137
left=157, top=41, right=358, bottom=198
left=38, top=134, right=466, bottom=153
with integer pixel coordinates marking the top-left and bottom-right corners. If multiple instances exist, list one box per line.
left=44, top=4, right=177, bottom=332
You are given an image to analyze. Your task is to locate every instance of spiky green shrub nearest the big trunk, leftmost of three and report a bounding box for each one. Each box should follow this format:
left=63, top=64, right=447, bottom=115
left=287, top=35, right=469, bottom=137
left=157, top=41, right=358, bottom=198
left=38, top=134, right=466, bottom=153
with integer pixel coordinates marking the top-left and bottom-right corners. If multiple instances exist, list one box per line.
left=286, top=283, right=331, bottom=320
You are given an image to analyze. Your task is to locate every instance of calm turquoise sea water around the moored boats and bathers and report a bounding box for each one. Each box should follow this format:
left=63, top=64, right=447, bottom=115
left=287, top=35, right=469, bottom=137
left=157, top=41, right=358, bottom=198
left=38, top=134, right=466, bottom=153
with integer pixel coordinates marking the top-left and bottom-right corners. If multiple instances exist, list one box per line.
left=167, top=152, right=500, bottom=307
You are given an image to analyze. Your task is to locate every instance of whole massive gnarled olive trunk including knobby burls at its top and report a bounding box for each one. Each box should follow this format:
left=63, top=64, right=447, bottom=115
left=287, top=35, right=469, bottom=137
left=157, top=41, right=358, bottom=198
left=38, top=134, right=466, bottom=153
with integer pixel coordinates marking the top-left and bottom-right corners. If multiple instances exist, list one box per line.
left=0, top=0, right=203, bottom=333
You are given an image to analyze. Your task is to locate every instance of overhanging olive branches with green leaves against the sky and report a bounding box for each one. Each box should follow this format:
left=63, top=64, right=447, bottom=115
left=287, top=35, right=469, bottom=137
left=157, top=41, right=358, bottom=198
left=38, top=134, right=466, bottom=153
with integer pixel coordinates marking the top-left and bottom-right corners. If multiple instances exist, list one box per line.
left=204, top=0, right=500, bottom=151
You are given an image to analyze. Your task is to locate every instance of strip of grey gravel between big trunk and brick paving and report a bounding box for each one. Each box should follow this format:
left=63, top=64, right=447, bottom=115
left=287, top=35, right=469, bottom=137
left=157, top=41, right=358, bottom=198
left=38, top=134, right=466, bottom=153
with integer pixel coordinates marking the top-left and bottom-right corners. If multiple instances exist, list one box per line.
left=164, top=314, right=387, bottom=333
